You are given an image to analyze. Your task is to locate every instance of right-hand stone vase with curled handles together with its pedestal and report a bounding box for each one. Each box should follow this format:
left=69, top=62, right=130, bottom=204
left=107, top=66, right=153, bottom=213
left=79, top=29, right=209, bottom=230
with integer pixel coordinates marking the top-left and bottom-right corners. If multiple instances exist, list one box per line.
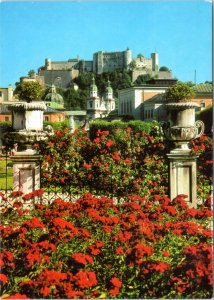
left=161, top=102, right=204, bottom=207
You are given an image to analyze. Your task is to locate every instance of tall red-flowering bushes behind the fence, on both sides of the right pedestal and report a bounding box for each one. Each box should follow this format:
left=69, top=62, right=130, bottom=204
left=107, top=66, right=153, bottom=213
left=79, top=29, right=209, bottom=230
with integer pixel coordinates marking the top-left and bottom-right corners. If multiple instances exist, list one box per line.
left=39, top=126, right=212, bottom=199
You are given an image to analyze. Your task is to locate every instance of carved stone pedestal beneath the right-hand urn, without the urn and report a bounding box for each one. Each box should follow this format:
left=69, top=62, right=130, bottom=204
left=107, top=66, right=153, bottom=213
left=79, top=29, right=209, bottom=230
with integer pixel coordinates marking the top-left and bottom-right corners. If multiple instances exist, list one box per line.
left=167, top=150, right=197, bottom=207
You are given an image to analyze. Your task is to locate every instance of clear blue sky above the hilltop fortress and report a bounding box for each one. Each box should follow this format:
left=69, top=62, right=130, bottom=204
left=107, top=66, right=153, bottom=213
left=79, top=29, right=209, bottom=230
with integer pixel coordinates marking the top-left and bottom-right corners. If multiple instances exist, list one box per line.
left=0, top=0, right=212, bottom=87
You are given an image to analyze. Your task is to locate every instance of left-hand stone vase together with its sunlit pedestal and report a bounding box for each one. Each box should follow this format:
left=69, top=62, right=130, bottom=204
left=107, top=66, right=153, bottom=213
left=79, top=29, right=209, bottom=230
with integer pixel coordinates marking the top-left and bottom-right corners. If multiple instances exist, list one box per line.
left=5, top=102, right=47, bottom=194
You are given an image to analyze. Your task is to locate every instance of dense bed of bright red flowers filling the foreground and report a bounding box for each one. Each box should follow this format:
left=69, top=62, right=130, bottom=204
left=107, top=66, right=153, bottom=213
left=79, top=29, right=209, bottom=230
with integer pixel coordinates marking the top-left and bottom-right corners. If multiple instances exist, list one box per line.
left=0, top=191, right=213, bottom=299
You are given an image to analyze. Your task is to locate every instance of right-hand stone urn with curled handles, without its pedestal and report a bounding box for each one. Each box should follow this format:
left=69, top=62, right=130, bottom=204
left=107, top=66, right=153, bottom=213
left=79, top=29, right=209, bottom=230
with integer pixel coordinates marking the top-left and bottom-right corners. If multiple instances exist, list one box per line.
left=161, top=102, right=204, bottom=151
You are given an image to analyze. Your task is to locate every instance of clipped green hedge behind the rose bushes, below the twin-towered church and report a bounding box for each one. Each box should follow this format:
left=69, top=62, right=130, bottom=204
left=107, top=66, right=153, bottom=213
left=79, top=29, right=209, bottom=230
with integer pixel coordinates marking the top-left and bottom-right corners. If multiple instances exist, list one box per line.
left=89, top=120, right=154, bottom=139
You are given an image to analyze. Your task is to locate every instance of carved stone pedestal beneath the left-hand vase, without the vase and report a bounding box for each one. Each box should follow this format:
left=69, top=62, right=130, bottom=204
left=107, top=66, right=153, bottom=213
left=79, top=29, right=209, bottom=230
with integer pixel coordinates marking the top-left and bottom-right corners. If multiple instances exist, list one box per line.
left=11, top=149, right=40, bottom=194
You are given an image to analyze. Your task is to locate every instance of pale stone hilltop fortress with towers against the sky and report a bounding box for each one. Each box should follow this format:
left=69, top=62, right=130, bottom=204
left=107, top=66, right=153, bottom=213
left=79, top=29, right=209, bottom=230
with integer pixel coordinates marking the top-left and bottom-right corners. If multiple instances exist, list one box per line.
left=37, top=48, right=172, bottom=88
